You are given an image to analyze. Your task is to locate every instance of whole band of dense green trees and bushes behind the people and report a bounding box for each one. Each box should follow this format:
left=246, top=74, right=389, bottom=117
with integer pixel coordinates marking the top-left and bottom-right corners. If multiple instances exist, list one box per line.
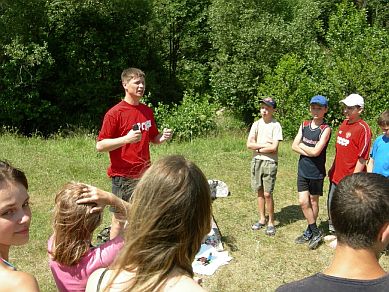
left=0, top=0, right=389, bottom=139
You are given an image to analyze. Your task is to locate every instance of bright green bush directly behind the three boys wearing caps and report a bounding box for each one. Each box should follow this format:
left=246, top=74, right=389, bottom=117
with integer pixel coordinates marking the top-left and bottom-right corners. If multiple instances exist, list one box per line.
left=253, top=2, right=389, bottom=138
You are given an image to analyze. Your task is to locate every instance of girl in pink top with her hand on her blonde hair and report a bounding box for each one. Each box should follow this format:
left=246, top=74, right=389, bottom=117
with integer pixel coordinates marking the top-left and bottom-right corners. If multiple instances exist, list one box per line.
left=48, top=182, right=128, bottom=292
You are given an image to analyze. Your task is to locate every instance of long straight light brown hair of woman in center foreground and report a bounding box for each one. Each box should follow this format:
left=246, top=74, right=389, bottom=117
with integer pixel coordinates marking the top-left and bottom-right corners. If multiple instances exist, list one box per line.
left=107, top=155, right=212, bottom=291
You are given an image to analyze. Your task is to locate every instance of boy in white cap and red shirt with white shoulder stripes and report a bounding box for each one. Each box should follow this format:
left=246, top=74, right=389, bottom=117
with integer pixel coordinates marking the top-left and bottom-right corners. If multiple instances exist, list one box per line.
left=327, top=94, right=371, bottom=232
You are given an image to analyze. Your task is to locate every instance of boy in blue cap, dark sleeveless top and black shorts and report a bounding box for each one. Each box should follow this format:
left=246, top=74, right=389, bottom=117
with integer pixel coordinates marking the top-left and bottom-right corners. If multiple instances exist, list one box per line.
left=292, top=95, right=331, bottom=249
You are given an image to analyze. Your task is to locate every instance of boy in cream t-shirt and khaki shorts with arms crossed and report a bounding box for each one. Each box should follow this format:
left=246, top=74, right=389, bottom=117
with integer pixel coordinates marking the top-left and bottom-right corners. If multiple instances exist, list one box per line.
left=247, top=97, right=283, bottom=236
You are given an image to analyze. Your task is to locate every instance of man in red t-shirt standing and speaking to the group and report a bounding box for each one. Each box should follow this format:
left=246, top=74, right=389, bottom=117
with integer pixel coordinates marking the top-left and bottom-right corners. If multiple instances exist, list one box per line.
left=96, top=68, right=172, bottom=238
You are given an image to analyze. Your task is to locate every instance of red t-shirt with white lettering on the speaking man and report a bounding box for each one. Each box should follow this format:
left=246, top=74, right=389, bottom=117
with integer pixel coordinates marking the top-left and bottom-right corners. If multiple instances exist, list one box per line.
left=97, top=100, right=159, bottom=178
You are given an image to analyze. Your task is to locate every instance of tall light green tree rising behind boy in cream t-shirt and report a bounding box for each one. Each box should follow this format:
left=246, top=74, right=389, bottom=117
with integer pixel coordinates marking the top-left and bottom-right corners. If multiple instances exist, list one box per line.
left=210, top=0, right=320, bottom=120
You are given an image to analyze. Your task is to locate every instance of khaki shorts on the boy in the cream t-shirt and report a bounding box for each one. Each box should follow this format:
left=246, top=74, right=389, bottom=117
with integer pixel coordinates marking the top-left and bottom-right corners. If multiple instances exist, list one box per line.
left=251, top=158, right=278, bottom=194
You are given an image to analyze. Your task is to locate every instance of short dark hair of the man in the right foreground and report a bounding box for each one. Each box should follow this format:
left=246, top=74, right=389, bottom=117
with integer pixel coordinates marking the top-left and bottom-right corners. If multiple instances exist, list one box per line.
left=330, top=173, right=389, bottom=249
